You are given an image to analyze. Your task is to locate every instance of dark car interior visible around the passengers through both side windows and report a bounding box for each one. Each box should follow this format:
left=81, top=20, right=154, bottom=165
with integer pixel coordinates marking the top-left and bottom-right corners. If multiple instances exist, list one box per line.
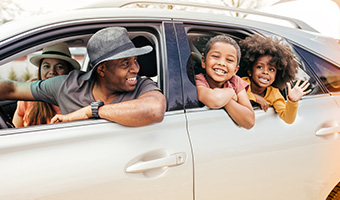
left=0, top=29, right=322, bottom=128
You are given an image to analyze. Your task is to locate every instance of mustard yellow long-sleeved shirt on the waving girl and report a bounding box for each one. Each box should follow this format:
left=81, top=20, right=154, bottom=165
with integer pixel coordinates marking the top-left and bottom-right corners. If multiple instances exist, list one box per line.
left=242, top=77, right=299, bottom=124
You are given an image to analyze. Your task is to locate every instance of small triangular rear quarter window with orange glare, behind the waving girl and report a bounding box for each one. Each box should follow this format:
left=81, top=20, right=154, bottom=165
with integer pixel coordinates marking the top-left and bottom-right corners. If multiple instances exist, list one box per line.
left=295, top=46, right=340, bottom=92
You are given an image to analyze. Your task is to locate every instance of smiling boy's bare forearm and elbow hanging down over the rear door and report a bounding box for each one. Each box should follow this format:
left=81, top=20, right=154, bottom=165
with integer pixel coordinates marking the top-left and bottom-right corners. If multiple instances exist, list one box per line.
left=224, top=89, right=255, bottom=129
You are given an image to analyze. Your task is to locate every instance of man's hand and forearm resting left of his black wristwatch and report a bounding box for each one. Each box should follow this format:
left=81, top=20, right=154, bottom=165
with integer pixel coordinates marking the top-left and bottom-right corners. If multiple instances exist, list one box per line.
left=51, top=106, right=92, bottom=124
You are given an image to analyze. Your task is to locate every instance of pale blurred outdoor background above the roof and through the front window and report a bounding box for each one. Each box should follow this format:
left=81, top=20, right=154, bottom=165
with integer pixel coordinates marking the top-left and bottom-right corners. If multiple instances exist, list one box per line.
left=0, top=0, right=340, bottom=81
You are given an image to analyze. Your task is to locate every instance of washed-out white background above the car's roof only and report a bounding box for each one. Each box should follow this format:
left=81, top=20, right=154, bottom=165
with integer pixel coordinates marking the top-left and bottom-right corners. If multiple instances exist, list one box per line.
left=0, top=0, right=340, bottom=39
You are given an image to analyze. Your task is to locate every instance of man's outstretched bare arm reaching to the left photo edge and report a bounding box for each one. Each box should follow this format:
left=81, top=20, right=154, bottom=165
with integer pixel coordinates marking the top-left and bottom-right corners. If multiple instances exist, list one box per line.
left=0, top=80, right=34, bottom=100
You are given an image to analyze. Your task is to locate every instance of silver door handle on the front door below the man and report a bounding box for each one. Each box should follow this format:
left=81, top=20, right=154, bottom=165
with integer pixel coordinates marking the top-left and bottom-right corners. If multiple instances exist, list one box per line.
left=125, top=152, right=186, bottom=173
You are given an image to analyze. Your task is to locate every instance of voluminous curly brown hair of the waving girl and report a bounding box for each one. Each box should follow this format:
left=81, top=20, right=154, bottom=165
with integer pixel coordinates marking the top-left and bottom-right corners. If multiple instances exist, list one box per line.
left=239, top=34, right=299, bottom=89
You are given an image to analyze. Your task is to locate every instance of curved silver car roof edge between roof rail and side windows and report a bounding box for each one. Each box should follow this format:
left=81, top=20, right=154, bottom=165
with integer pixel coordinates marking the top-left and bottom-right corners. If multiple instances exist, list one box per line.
left=0, top=8, right=340, bottom=64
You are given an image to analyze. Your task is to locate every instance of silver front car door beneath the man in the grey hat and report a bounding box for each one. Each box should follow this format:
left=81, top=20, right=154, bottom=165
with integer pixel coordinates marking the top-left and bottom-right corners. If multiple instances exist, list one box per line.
left=0, top=21, right=193, bottom=200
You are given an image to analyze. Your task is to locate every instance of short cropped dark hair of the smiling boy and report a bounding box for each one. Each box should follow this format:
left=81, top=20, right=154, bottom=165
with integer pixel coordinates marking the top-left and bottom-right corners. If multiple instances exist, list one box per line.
left=204, top=34, right=241, bottom=65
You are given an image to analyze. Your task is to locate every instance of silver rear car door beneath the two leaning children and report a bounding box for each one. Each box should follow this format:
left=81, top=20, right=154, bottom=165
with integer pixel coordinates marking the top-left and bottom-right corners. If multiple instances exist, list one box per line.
left=177, top=23, right=340, bottom=200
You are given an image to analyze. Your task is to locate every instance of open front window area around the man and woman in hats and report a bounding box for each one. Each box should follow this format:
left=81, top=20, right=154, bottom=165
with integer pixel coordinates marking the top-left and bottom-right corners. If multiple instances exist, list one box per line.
left=0, top=28, right=160, bottom=128
